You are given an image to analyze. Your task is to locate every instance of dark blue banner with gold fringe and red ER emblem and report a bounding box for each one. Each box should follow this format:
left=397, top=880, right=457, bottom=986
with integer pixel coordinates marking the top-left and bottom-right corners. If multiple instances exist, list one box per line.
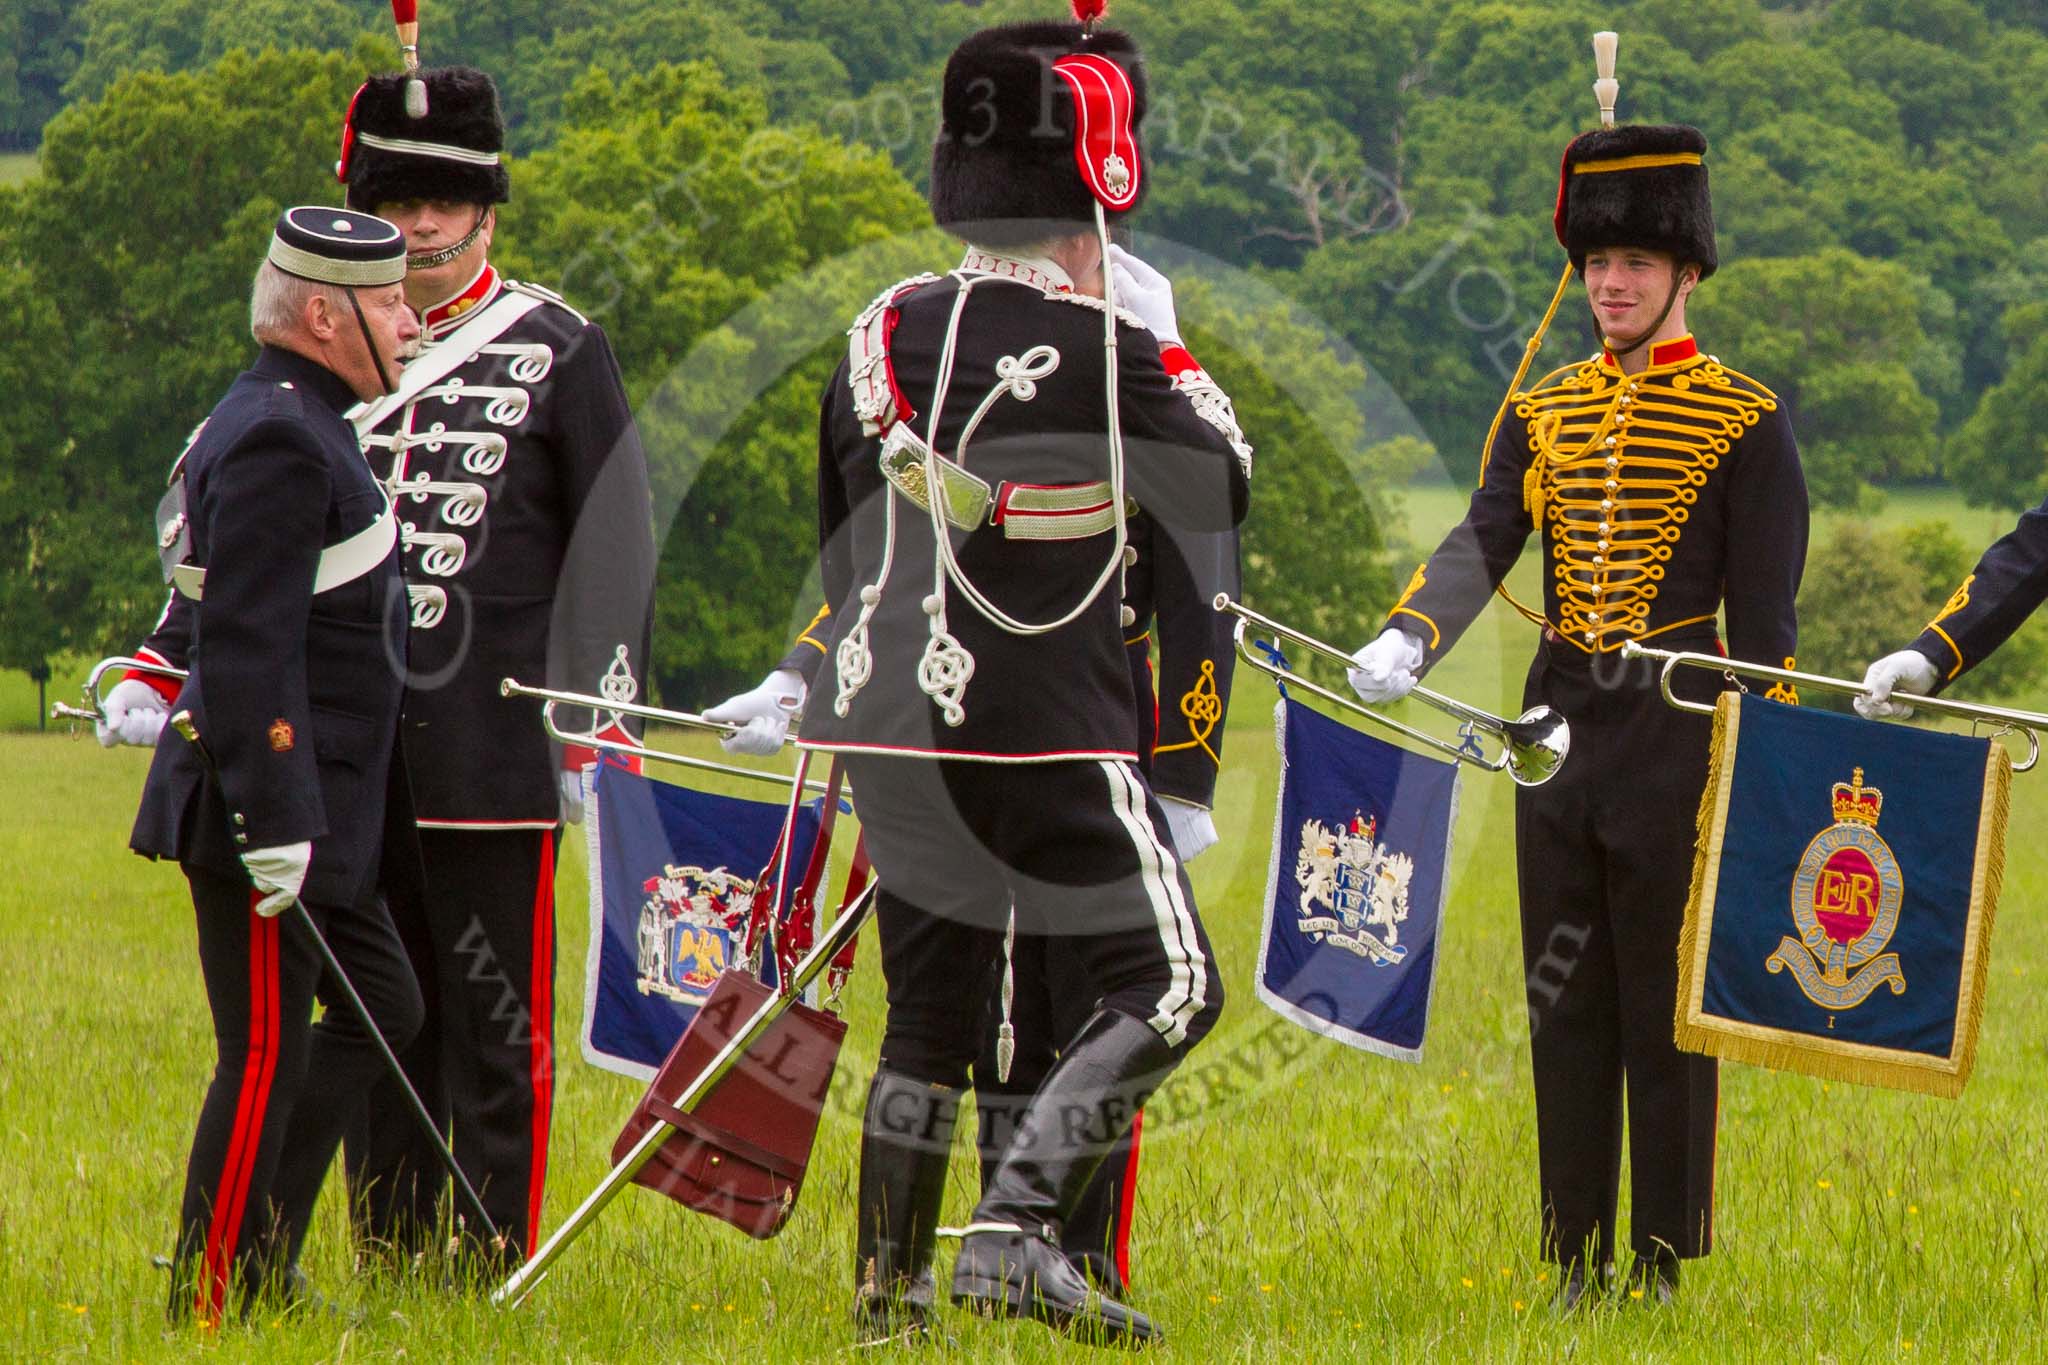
left=1675, top=692, right=2011, bottom=1097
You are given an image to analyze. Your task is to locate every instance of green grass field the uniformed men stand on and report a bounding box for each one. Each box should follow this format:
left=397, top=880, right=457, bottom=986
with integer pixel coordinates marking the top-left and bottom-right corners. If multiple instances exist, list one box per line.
left=12, top=585, right=2048, bottom=1365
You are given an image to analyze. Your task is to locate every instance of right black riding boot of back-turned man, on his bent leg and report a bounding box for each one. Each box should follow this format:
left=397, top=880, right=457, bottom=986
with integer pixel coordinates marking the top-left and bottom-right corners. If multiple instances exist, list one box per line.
left=952, top=1011, right=1180, bottom=1340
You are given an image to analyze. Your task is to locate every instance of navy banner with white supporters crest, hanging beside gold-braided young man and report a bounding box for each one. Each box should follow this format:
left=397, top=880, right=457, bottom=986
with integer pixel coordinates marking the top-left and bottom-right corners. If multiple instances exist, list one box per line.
left=1257, top=700, right=1458, bottom=1062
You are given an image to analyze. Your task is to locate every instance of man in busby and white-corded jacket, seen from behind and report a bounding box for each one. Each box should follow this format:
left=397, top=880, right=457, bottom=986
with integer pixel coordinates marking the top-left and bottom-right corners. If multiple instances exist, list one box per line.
left=774, top=4, right=1249, bottom=1338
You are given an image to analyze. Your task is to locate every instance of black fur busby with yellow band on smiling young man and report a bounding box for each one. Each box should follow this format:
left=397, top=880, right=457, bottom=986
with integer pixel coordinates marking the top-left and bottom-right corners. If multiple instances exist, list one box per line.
left=1556, top=123, right=1720, bottom=280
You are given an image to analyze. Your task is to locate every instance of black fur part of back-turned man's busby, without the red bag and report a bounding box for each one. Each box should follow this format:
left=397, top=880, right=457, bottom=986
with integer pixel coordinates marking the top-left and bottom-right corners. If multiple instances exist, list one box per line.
left=932, top=17, right=1145, bottom=246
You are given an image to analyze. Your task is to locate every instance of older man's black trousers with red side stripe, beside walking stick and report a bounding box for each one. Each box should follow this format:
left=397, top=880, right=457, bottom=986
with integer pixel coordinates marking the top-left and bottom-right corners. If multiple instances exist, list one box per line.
left=170, top=866, right=422, bottom=1322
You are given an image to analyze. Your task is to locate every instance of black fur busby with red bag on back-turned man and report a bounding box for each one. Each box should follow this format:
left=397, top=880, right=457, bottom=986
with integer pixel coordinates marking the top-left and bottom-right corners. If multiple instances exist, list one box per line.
left=932, top=0, right=1145, bottom=248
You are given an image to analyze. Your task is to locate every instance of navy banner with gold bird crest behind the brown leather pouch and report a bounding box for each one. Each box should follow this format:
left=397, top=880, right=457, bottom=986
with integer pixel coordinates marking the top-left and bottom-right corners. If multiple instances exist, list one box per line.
left=584, top=761, right=817, bottom=1081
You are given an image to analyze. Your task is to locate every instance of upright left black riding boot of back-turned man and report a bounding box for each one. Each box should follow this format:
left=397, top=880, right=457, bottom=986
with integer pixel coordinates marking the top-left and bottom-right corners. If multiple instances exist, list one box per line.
left=854, top=1070, right=961, bottom=1345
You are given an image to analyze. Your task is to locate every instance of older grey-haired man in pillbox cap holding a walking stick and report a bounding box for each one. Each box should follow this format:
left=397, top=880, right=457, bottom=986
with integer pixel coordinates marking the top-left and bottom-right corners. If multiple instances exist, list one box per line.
left=131, top=209, right=420, bottom=1324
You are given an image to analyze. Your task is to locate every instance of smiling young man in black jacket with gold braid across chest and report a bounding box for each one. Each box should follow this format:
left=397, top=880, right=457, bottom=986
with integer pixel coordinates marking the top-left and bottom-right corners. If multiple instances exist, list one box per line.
left=1352, top=127, right=1806, bottom=1308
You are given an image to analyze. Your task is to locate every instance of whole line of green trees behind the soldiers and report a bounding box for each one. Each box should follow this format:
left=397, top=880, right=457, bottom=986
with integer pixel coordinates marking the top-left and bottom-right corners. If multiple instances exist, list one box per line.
left=0, top=0, right=2048, bottom=700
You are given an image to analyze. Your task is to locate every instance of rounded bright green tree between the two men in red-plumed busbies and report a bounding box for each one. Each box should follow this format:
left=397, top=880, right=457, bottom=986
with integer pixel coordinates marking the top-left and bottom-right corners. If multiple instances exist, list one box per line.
left=496, top=63, right=934, bottom=704
